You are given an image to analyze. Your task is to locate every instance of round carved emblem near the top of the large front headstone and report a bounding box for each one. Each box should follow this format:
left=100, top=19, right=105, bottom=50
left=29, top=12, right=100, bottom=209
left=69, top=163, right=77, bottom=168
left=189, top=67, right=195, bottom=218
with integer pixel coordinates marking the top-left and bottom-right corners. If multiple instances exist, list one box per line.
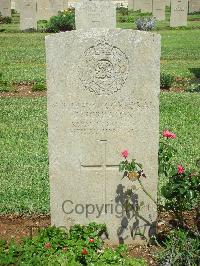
left=79, top=40, right=129, bottom=95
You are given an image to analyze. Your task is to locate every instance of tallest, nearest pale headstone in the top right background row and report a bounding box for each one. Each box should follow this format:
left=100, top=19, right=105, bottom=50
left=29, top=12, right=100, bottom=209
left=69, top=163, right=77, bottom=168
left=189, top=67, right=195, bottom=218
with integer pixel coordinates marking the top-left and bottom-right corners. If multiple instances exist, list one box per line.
left=170, top=0, right=188, bottom=27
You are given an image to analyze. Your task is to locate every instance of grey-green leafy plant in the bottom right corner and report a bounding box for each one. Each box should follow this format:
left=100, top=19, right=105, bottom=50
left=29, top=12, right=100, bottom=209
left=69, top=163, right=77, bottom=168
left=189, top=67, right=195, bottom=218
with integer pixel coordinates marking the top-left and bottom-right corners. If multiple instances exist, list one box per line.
left=156, top=230, right=200, bottom=266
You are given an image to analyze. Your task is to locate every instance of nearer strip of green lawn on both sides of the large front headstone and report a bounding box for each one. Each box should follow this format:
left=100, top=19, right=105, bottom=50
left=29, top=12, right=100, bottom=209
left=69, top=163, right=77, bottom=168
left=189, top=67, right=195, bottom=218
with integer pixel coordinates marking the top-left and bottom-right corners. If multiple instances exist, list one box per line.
left=0, top=93, right=200, bottom=213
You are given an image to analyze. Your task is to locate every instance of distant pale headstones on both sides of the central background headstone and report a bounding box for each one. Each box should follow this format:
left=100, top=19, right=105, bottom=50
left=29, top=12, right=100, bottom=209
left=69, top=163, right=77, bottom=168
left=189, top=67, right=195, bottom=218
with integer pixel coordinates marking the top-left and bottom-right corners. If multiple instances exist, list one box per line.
left=0, top=0, right=200, bottom=30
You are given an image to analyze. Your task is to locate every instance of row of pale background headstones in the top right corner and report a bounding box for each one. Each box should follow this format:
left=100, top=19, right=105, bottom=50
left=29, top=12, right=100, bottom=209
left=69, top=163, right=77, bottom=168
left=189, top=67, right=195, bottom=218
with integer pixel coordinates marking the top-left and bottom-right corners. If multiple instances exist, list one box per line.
left=128, top=0, right=200, bottom=27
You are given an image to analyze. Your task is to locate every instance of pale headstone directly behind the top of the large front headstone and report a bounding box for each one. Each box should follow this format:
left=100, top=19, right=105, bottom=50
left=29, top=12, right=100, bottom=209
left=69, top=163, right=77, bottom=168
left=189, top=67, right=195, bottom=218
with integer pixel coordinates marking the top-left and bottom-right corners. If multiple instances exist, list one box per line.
left=75, top=0, right=116, bottom=30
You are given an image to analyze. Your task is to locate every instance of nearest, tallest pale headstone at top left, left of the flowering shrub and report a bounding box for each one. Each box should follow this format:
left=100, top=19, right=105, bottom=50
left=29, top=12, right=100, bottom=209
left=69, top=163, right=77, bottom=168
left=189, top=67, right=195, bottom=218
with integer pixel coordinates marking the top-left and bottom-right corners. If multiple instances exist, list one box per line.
left=20, top=0, right=37, bottom=30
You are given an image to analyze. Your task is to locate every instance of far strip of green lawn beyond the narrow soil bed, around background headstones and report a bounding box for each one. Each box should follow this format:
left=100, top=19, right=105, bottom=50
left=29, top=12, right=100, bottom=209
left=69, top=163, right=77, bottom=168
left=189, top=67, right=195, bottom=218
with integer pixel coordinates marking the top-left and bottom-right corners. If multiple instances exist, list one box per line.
left=0, top=10, right=200, bottom=83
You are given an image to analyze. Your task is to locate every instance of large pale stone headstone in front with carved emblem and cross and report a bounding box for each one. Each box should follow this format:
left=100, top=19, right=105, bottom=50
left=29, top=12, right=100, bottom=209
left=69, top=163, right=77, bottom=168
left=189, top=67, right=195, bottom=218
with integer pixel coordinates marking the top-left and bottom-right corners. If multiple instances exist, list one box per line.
left=46, top=29, right=160, bottom=243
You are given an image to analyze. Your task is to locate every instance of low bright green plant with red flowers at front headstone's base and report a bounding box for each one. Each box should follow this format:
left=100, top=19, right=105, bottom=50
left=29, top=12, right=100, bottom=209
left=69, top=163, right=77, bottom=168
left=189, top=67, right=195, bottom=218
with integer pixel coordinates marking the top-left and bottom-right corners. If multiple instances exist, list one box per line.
left=0, top=223, right=146, bottom=266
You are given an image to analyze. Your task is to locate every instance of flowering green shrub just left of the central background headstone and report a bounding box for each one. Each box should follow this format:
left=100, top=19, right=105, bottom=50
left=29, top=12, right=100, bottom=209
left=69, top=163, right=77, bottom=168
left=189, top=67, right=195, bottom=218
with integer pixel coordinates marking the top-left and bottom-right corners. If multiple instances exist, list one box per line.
left=45, top=9, right=75, bottom=32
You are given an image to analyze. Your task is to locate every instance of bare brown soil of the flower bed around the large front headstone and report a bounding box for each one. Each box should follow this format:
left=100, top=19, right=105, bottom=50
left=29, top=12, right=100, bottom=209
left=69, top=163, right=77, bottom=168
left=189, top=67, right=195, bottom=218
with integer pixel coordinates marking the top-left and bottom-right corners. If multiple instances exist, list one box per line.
left=0, top=211, right=200, bottom=266
